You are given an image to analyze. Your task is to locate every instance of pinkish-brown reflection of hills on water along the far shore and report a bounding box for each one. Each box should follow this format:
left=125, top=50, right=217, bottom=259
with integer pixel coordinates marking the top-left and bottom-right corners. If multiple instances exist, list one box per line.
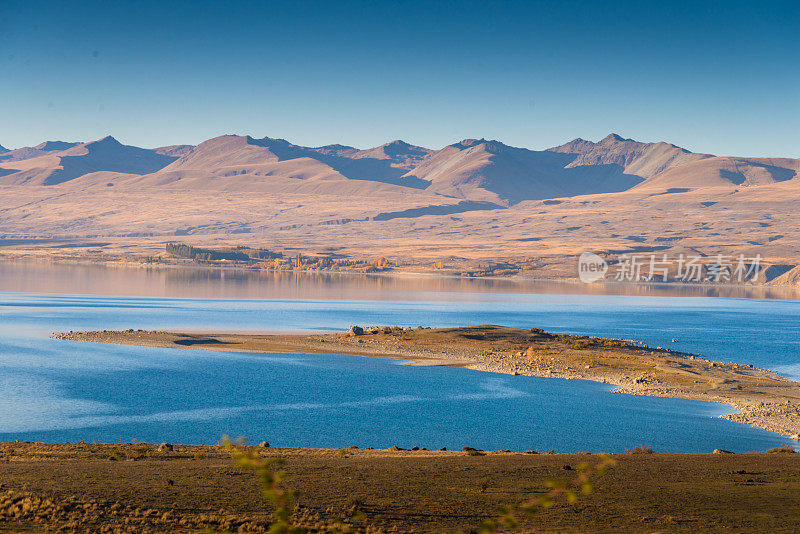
left=0, top=261, right=800, bottom=300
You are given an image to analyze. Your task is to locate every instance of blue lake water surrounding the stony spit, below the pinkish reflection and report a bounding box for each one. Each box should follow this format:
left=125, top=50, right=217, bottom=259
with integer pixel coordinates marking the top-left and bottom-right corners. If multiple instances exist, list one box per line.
left=0, top=270, right=800, bottom=452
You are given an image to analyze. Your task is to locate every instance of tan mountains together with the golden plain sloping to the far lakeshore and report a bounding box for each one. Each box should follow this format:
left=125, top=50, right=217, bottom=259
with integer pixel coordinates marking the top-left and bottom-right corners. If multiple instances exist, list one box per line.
left=0, top=134, right=800, bottom=284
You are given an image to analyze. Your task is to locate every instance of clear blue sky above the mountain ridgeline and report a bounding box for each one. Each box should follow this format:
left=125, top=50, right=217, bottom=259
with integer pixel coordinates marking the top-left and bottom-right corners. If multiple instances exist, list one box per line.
left=0, top=0, right=800, bottom=157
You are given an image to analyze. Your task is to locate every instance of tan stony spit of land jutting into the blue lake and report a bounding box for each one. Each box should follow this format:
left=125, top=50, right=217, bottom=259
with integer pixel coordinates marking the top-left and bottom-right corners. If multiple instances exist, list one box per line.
left=54, top=325, right=800, bottom=440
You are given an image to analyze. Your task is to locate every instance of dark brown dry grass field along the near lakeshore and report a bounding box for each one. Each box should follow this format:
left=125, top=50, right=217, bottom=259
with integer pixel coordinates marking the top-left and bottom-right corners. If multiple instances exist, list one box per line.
left=0, top=442, right=800, bottom=533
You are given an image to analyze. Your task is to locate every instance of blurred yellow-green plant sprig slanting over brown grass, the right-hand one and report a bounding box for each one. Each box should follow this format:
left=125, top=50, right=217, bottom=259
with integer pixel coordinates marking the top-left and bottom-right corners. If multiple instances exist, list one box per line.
left=480, top=454, right=617, bottom=534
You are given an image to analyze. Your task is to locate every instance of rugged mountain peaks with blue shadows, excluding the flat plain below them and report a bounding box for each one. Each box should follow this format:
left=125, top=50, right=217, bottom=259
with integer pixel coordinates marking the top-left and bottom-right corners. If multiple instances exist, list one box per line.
left=0, top=134, right=800, bottom=206
